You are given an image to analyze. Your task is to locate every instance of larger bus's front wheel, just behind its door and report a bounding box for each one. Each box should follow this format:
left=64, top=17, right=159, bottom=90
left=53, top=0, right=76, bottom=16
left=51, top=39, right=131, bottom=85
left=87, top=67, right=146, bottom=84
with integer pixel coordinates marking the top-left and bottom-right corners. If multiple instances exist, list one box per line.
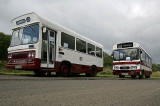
left=60, top=63, right=70, bottom=77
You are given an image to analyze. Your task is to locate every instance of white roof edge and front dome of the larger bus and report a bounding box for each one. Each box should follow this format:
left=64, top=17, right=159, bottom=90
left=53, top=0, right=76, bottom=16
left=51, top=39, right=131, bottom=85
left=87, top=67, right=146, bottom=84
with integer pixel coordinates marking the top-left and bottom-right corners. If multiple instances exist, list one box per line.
left=11, top=12, right=103, bottom=48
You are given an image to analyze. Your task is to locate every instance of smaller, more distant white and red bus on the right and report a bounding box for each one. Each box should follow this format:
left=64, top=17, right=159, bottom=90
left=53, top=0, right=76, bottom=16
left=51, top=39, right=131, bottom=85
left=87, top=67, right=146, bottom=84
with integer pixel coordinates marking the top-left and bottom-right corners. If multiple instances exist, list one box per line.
left=112, top=42, right=152, bottom=78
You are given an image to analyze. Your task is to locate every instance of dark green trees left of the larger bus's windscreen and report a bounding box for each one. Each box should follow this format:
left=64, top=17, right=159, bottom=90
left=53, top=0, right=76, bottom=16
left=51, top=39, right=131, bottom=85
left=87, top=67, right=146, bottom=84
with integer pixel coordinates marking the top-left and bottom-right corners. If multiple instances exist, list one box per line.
left=0, top=32, right=11, bottom=60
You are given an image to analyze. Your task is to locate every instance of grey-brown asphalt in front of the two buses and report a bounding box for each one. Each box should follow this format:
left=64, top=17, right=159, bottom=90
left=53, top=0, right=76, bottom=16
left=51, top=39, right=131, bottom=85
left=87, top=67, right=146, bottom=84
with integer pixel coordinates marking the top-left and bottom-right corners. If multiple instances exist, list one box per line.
left=0, top=75, right=160, bottom=106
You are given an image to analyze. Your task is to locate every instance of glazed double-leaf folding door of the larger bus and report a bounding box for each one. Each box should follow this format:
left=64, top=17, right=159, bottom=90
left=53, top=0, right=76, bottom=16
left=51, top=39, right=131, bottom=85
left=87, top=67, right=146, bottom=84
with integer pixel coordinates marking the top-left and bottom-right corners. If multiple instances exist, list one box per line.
left=41, top=29, right=56, bottom=68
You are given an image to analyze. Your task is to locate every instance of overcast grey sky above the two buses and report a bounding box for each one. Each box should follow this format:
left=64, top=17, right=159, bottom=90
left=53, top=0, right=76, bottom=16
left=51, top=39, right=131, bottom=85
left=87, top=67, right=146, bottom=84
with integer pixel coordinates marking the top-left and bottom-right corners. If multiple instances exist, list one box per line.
left=0, top=0, right=160, bottom=63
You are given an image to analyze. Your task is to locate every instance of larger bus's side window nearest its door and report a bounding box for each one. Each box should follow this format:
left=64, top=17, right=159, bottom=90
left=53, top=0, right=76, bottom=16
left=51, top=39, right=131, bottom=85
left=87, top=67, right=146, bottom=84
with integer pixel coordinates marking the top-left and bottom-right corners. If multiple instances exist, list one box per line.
left=61, top=32, right=75, bottom=50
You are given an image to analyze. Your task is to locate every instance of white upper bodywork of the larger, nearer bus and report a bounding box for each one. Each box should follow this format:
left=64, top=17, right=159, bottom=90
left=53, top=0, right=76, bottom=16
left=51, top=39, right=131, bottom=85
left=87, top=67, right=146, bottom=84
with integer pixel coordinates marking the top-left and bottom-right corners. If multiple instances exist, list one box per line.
left=8, top=13, right=103, bottom=67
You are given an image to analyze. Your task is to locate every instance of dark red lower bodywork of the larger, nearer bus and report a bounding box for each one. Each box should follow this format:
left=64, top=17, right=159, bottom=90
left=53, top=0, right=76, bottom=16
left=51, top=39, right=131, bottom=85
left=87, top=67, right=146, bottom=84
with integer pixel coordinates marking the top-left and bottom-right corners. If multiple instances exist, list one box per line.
left=6, top=51, right=103, bottom=73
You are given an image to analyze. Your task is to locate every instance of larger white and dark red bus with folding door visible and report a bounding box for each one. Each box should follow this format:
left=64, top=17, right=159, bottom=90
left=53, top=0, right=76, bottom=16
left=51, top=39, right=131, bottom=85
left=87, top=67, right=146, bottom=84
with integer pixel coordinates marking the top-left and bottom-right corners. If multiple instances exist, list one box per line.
left=7, top=13, right=103, bottom=76
